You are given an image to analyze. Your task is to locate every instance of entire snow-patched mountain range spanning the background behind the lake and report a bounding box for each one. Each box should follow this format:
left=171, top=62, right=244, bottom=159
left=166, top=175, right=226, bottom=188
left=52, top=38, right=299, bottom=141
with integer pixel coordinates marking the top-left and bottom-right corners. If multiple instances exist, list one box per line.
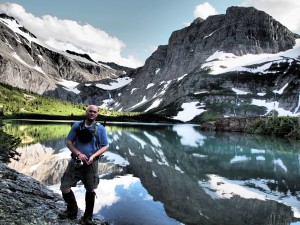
left=0, top=7, right=300, bottom=122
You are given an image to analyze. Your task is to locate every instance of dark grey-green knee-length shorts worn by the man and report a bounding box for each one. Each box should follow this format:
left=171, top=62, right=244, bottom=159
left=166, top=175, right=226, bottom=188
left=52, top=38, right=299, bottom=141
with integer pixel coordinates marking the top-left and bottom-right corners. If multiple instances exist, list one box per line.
left=60, top=159, right=99, bottom=191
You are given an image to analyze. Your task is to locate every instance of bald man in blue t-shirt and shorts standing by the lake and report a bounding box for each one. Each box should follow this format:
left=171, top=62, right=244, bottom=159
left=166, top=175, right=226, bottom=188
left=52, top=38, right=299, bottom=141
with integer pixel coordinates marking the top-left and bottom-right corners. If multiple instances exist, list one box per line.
left=59, top=105, right=108, bottom=224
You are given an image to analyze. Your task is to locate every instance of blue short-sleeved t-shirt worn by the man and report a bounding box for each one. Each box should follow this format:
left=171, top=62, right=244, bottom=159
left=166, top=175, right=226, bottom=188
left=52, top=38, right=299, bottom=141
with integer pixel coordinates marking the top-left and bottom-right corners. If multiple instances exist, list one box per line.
left=66, top=121, right=108, bottom=158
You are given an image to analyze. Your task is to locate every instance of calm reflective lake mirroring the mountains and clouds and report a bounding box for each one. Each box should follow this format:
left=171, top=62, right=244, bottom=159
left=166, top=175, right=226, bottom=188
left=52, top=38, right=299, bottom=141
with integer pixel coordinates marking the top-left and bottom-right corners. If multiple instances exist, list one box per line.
left=4, top=120, right=300, bottom=225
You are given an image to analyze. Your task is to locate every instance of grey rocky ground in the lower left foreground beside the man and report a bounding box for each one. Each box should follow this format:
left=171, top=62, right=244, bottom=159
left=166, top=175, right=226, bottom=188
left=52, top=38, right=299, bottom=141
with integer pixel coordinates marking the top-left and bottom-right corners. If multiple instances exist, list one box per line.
left=0, top=162, right=97, bottom=225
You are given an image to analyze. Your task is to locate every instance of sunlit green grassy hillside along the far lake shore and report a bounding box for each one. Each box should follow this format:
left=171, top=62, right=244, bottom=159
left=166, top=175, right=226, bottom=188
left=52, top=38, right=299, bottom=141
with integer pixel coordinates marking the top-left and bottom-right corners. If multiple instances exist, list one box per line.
left=0, top=83, right=140, bottom=118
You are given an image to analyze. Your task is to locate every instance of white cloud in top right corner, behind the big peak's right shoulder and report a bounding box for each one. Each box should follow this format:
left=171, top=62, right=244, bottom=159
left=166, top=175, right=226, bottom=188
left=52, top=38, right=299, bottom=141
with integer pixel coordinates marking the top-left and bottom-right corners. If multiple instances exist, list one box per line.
left=241, top=0, right=300, bottom=34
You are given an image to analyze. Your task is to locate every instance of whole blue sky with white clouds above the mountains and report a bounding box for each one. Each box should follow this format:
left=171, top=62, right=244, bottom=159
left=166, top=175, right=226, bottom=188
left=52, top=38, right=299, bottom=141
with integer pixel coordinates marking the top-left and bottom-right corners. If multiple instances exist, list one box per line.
left=0, top=0, right=300, bottom=67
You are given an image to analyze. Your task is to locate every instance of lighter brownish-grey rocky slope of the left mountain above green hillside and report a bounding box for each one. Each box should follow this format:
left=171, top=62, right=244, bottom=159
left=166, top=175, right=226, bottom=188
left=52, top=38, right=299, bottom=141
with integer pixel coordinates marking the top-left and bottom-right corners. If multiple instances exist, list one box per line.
left=0, top=14, right=124, bottom=97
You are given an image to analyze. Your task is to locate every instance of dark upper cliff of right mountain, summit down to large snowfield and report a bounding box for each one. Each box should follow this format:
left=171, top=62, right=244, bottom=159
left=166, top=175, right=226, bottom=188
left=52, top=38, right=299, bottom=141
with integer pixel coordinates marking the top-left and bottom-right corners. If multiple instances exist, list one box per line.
left=131, top=7, right=298, bottom=86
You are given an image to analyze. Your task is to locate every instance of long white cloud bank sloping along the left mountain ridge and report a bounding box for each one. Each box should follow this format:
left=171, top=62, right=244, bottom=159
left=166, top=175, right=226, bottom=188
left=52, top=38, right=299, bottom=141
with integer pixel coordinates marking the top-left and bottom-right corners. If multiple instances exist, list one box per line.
left=0, top=3, right=142, bottom=67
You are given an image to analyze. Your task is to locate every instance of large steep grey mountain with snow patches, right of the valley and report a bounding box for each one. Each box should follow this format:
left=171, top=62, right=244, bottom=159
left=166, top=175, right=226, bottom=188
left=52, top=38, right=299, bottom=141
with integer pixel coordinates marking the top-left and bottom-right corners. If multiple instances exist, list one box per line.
left=111, top=7, right=300, bottom=120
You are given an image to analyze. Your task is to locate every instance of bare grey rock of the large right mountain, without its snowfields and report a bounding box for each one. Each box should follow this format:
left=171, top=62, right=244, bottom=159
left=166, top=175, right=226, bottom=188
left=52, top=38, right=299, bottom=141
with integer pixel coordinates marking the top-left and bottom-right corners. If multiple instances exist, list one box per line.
left=111, top=7, right=300, bottom=116
